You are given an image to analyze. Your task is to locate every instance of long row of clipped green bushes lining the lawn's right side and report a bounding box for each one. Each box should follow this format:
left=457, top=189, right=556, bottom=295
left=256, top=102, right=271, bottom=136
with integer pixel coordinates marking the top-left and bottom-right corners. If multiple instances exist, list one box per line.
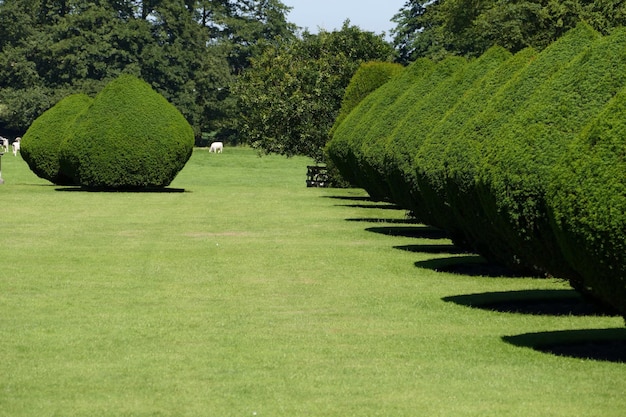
left=327, top=24, right=626, bottom=315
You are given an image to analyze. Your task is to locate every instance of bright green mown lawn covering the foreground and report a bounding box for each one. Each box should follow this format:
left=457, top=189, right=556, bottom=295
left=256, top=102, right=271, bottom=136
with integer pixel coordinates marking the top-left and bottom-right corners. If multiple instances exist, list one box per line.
left=0, top=148, right=626, bottom=417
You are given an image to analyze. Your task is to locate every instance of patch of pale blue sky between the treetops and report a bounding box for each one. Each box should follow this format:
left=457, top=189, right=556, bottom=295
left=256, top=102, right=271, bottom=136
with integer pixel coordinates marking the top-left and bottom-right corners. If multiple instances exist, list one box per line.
left=282, top=0, right=406, bottom=35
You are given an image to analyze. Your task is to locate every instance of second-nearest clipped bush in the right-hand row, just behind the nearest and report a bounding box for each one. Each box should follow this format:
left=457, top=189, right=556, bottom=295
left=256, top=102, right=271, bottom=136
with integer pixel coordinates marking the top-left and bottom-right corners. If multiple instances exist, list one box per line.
left=478, top=25, right=626, bottom=280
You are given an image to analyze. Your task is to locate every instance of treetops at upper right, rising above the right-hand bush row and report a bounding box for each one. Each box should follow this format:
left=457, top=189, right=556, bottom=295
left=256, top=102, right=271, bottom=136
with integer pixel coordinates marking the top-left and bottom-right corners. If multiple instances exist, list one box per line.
left=392, top=0, right=626, bottom=62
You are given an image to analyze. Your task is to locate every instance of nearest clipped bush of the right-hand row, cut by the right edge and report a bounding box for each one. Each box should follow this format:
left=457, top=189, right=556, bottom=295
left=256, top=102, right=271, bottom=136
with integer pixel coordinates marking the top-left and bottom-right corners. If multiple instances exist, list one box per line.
left=546, top=88, right=626, bottom=317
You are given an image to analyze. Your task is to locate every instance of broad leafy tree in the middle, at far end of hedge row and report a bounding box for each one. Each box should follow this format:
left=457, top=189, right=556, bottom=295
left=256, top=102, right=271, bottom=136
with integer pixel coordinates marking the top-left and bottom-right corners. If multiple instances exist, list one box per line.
left=234, top=22, right=393, bottom=161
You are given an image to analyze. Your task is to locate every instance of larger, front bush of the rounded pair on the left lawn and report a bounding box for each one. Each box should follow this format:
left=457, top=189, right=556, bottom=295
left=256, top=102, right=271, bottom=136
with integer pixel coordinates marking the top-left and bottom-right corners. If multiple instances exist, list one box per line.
left=61, top=75, right=194, bottom=189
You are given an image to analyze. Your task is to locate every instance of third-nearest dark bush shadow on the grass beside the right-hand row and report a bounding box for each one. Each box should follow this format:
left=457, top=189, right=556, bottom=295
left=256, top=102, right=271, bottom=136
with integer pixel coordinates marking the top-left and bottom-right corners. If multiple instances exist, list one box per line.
left=415, top=254, right=528, bottom=278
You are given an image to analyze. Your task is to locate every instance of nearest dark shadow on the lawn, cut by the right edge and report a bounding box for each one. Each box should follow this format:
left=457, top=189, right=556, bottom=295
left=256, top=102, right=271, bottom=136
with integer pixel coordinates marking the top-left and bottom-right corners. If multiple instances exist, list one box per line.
left=502, top=328, right=626, bottom=363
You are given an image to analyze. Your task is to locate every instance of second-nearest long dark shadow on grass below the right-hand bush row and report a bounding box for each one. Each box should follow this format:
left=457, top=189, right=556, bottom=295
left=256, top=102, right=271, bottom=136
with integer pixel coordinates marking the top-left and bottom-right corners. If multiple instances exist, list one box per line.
left=443, top=289, right=612, bottom=316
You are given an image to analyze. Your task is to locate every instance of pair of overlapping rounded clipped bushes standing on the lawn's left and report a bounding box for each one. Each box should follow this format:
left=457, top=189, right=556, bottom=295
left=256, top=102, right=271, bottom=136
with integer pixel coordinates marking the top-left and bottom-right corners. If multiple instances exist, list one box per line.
left=21, top=75, right=194, bottom=189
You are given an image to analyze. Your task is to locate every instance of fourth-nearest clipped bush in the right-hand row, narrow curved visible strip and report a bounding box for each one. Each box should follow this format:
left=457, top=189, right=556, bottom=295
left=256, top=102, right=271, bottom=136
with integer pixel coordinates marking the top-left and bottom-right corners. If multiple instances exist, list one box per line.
left=414, top=48, right=537, bottom=246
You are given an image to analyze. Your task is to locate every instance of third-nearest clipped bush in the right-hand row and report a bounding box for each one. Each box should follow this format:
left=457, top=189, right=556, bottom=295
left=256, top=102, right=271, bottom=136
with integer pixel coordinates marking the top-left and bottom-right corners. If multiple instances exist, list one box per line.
left=436, top=24, right=599, bottom=270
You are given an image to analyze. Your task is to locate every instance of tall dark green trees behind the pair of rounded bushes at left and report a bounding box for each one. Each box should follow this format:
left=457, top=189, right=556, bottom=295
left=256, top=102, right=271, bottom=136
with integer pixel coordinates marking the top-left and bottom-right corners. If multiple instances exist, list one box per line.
left=0, top=0, right=295, bottom=140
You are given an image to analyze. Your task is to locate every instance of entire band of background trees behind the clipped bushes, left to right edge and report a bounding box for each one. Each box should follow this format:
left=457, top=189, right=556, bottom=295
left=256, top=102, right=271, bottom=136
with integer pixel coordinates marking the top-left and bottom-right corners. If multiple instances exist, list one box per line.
left=0, top=0, right=626, bottom=159
